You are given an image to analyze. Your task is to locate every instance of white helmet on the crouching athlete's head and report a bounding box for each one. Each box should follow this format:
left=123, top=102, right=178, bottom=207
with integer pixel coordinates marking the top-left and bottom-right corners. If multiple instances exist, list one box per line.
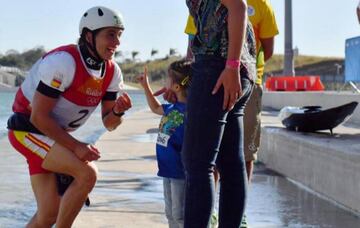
left=79, top=6, right=124, bottom=36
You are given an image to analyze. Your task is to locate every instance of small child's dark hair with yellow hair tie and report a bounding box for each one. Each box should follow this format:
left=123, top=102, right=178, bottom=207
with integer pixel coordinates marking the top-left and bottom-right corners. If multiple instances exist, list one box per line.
left=169, top=59, right=192, bottom=97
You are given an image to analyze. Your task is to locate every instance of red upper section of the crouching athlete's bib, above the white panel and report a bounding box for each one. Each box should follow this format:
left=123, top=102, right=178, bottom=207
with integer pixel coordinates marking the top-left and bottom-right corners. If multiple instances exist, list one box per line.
left=44, top=45, right=114, bottom=106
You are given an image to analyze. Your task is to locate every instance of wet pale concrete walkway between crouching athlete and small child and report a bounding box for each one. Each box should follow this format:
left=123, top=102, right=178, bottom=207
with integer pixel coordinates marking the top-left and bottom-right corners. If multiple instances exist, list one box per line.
left=74, top=111, right=167, bottom=228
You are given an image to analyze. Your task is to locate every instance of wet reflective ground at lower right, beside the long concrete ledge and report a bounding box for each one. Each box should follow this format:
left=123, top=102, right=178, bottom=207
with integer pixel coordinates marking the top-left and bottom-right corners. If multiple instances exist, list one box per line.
left=246, top=165, right=360, bottom=228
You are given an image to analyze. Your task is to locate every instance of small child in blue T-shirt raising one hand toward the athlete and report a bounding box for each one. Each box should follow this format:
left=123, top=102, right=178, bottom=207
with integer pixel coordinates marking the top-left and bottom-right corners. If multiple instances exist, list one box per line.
left=137, top=60, right=191, bottom=228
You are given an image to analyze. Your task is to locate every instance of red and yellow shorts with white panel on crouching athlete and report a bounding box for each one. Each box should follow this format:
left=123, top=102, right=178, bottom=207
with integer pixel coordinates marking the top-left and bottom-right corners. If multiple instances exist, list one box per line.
left=8, top=130, right=55, bottom=175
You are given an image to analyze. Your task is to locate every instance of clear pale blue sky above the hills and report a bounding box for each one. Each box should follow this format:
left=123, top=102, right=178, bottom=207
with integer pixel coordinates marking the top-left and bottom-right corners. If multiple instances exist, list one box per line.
left=0, top=0, right=360, bottom=60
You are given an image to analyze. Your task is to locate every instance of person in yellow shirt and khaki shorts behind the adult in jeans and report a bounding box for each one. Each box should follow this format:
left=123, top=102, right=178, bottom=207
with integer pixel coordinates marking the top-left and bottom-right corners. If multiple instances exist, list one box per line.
left=244, top=0, right=279, bottom=182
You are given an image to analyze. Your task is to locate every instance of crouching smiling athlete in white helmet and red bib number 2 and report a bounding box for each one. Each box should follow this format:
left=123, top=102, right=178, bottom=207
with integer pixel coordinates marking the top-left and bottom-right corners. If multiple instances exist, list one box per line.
left=8, top=6, right=131, bottom=227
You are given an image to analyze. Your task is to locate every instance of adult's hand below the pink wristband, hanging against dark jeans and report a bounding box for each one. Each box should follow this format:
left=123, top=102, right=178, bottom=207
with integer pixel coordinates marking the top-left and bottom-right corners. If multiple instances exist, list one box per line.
left=212, top=68, right=242, bottom=111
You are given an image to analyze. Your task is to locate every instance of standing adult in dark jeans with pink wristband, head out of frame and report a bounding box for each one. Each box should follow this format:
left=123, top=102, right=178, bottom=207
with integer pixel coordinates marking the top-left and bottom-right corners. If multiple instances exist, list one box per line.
left=183, top=0, right=256, bottom=228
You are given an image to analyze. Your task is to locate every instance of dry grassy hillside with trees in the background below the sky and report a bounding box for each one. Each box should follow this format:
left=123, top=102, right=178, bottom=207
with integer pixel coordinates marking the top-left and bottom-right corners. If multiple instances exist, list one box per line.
left=0, top=52, right=344, bottom=89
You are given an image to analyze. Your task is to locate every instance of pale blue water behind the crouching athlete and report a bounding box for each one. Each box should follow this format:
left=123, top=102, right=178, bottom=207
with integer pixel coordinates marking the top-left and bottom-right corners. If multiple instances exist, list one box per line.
left=0, top=90, right=147, bottom=144
